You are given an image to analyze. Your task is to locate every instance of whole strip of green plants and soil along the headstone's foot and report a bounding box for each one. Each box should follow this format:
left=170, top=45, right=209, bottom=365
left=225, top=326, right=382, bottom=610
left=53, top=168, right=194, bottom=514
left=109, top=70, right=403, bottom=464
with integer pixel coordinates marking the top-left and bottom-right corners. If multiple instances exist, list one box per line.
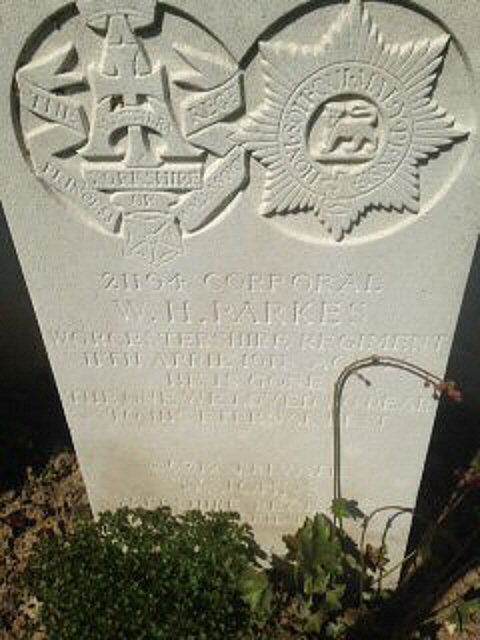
left=0, top=454, right=480, bottom=640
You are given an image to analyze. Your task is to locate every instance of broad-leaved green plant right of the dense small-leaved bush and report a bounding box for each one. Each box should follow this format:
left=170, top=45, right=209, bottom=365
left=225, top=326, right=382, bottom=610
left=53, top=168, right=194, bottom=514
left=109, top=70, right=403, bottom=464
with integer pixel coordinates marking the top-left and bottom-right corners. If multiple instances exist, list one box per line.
left=241, top=499, right=385, bottom=638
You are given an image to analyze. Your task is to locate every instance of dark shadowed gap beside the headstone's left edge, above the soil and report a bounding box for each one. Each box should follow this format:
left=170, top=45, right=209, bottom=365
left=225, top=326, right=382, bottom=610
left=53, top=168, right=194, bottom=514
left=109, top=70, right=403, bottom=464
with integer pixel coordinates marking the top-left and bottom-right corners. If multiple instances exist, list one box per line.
left=0, top=206, right=72, bottom=490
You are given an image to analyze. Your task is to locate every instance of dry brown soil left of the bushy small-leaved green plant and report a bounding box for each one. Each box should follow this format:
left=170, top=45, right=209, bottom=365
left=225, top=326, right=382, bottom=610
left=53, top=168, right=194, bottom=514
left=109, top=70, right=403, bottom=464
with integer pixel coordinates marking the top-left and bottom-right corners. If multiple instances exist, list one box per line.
left=0, top=453, right=480, bottom=640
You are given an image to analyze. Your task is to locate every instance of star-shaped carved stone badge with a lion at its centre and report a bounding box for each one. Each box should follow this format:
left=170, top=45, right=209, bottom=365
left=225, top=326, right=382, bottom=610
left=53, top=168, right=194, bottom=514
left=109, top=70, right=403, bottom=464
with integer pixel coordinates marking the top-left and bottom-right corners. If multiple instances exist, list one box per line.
left=234, top=0, right=468, bottom=241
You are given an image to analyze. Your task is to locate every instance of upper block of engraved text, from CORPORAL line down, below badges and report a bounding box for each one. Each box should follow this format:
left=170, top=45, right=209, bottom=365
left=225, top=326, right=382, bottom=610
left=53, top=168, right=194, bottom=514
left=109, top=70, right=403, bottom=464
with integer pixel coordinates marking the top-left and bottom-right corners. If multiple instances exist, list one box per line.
left=52, top=271, right=450, bottom=434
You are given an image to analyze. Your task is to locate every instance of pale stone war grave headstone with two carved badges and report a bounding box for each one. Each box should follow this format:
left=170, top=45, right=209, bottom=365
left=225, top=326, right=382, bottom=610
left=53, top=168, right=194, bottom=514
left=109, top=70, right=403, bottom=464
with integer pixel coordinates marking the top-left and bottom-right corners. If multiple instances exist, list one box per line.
left=0, top=0, right=480, bottom=568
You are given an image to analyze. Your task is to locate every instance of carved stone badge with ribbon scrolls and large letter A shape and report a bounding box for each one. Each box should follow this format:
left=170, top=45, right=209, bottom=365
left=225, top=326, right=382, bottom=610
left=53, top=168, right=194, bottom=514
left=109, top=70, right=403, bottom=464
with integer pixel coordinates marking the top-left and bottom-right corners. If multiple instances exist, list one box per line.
left=17, top=0, right=247, bottom=266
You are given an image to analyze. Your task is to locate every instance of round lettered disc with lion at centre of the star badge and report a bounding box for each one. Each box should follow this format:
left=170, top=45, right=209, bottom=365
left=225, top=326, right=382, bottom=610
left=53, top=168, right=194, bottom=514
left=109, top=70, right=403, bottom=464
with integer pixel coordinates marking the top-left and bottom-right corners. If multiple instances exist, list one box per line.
left=280, top=64, right=414, bottom=200
